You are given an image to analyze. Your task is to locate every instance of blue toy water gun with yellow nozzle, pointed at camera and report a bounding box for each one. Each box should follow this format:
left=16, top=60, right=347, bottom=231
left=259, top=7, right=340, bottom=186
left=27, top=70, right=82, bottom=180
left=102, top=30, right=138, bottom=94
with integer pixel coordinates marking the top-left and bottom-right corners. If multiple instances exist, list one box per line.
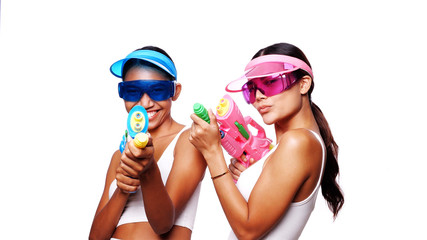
left=120, top=105, right=148, bottom=153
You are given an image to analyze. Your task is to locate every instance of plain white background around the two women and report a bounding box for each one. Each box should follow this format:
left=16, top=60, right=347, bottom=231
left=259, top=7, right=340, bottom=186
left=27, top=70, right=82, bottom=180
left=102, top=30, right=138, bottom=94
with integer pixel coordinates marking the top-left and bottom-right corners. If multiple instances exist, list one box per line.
left=0, top=0, right=427, bottom=239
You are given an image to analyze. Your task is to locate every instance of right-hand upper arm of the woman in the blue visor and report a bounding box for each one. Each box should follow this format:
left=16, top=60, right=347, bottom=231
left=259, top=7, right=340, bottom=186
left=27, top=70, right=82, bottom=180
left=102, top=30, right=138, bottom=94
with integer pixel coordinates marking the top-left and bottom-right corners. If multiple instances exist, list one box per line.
left=166, top=129, right=206, bottom=213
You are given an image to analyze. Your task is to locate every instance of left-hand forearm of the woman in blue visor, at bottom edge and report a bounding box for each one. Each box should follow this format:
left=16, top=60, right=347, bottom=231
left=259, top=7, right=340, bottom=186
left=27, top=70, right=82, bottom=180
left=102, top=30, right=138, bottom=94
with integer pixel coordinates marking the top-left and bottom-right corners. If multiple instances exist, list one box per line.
left=89, top=189, right=129, bottom=239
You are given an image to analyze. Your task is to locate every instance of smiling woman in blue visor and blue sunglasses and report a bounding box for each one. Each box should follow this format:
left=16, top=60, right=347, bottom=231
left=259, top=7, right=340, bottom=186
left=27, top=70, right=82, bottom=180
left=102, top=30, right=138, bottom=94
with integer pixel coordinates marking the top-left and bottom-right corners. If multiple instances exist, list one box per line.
left=89, top=46, right=206, bottom=239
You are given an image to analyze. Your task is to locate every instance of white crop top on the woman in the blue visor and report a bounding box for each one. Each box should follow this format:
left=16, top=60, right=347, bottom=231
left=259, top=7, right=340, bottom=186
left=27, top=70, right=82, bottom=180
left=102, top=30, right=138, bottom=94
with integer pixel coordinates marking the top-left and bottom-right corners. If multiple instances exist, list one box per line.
left=109, top=128, right=201, bottom=230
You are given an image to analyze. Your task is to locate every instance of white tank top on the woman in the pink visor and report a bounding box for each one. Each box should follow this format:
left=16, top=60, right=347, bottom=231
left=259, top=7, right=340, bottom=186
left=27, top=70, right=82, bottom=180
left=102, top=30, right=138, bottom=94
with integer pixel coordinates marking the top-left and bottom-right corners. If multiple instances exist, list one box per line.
left=229, top=130, right=326, bottom=240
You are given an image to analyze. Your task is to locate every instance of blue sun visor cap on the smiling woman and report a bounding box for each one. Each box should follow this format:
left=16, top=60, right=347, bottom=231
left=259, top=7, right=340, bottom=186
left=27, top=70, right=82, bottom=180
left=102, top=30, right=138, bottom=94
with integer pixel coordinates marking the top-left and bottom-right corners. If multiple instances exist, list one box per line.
left=110, top=50, right=176, bottom=79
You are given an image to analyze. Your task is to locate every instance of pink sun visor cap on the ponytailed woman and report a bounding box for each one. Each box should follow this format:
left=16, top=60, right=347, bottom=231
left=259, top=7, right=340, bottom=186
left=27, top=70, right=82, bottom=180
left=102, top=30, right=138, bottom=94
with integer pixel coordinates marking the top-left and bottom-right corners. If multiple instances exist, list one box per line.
left=225, top=54, right=313, bottom=92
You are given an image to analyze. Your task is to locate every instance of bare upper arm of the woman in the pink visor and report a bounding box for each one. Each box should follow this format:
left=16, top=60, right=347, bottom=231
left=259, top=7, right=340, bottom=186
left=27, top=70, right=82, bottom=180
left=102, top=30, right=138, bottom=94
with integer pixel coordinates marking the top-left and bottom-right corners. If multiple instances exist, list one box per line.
left=244, top=131, right=320, bottom=234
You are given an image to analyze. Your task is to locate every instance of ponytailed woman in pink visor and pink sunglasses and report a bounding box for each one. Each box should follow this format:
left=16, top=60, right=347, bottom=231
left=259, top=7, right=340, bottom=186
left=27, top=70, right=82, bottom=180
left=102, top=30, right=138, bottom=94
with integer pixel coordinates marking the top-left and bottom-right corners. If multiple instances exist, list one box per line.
left=190, top=43, right=344, bottom=239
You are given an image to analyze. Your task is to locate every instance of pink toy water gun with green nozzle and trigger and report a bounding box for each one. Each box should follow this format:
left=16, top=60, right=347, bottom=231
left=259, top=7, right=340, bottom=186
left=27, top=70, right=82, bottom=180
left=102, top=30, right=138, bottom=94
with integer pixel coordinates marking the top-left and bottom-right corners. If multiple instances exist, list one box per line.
left=193, top=94, right=273, bottom=167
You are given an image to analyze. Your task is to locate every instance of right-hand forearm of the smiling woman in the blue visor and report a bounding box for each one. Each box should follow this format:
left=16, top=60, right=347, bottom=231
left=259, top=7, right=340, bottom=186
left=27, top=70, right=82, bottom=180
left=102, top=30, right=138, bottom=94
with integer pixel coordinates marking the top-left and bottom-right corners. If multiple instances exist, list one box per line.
left=140, top=163, right=175, bottom=235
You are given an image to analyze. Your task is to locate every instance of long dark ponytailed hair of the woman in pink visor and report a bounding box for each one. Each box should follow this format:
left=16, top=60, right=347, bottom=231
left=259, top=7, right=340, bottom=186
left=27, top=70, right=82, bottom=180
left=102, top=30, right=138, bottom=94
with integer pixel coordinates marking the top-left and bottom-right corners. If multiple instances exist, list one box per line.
left=253, top=43, right=344, bottom=219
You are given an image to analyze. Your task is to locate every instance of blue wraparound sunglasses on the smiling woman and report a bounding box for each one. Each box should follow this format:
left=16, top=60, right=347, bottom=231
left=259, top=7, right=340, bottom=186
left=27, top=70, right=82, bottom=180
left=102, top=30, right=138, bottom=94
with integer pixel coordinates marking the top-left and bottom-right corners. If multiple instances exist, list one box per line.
left=119, top=80, right=175, bottom=102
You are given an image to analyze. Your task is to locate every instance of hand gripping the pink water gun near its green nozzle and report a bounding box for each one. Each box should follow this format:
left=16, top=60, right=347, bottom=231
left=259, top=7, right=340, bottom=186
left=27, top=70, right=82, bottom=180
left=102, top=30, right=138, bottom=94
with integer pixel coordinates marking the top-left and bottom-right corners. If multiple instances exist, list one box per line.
left=189, top=109, right=221, bottom=159
